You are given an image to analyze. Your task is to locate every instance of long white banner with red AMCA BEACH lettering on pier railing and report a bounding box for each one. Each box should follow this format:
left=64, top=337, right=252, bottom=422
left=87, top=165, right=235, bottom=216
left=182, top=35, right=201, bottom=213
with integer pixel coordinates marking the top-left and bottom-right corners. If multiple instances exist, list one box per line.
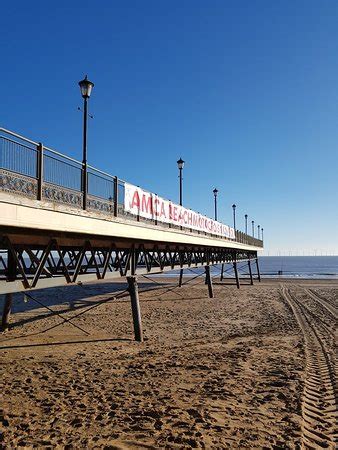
left=124, top=183, right=235, bottom=239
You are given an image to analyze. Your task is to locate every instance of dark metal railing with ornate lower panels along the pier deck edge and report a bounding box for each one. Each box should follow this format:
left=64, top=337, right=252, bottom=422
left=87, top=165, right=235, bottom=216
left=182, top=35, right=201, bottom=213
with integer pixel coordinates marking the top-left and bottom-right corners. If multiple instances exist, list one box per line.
left=0, top=128, right=263, bottom=247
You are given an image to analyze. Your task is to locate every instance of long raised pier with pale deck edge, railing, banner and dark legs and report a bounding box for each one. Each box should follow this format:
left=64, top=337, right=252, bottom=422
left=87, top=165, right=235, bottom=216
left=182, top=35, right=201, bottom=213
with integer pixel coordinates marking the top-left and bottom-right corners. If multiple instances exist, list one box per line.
left=0, top=128, right=263, bottom=340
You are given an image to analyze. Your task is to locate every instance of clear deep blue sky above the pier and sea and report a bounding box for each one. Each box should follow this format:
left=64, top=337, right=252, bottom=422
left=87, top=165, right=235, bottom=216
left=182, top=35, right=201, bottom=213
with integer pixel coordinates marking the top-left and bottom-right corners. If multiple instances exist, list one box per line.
left=0, top=0, right=338, bottom=254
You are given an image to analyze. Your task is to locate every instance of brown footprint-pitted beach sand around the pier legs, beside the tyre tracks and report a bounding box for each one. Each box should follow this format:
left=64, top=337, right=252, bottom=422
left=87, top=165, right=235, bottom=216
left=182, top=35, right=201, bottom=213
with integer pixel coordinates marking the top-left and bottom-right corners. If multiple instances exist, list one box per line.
left=0, top=275, right=338, bottom=449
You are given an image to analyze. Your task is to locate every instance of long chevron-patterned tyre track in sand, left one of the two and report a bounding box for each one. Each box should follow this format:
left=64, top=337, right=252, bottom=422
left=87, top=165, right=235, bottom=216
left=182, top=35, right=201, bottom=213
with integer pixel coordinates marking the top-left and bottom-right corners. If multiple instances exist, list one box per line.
left=281, top=285, right=338, bottom=450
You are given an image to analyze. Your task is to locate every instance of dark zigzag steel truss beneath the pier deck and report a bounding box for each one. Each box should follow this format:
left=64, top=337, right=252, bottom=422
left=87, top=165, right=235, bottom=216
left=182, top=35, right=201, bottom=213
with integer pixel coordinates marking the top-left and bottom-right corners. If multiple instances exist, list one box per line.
left=0, top=235, right=260, bottom=294
